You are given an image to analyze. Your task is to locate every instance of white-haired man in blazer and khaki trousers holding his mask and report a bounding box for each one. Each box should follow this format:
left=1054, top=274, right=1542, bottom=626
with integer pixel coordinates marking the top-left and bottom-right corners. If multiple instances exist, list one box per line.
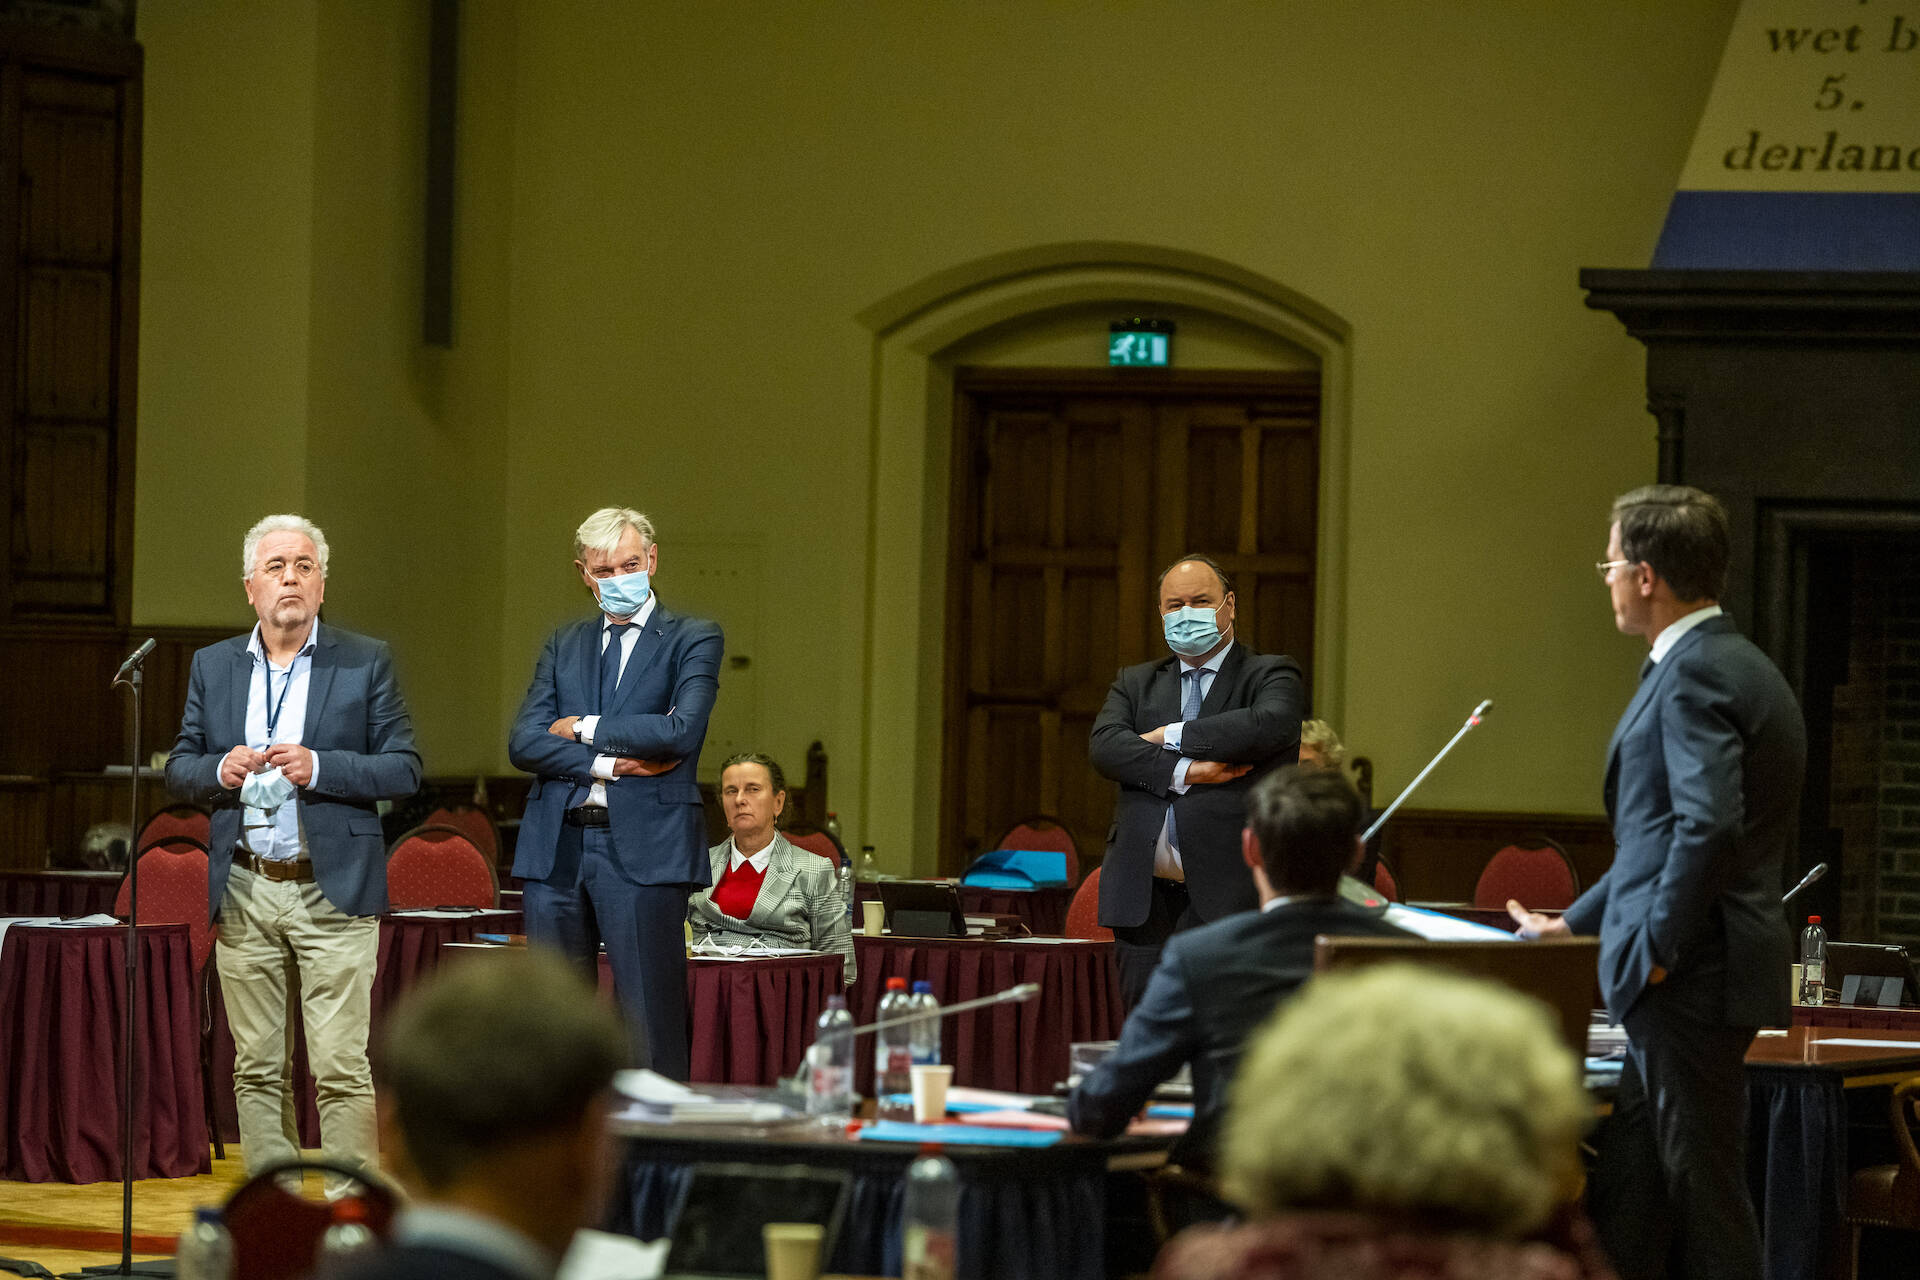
left=167, top=516, right=420, bottom=1197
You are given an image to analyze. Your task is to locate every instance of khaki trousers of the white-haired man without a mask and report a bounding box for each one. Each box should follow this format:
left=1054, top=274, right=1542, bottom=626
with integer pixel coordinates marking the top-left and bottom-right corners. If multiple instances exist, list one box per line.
left=213, top=865, right=380, bottom=1194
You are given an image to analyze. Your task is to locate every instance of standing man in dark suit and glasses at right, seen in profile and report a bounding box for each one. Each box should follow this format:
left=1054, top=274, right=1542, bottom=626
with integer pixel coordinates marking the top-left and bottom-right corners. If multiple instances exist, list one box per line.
left=1507, top=486, right=1807, bottom=1280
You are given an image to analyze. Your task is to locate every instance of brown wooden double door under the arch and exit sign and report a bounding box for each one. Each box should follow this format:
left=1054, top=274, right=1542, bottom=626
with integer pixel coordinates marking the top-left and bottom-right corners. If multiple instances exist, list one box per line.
left=941, top=370, right=1319, bottom=873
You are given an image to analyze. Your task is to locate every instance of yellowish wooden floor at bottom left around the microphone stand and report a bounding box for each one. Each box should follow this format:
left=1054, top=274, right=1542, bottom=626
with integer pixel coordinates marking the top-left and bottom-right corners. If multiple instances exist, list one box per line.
left=0, top=1146, right=244, bottom=1276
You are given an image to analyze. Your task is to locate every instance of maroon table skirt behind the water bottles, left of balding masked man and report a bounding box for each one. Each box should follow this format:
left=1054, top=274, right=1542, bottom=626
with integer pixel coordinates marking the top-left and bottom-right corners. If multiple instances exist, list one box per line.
left=847, top=935, right=1127, bottom=1094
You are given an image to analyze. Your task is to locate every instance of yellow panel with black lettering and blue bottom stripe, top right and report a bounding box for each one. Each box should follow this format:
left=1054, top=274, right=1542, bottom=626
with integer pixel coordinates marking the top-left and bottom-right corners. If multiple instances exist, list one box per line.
left=1653, top=0, right=1920, bottom=271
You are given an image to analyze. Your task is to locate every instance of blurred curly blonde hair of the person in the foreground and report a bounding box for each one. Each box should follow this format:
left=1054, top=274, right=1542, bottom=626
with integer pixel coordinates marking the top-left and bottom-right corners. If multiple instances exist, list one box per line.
left=1221, top=963, right=1592, bottom=1238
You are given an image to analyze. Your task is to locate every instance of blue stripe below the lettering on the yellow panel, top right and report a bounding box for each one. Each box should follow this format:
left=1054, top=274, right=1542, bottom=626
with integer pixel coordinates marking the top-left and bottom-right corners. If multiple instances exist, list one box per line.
left=1653, top=192, right=1920, bottom=271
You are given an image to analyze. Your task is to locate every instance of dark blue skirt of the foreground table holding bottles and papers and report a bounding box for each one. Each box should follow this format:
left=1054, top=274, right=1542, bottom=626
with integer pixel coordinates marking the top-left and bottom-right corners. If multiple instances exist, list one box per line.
left=609, top=1144, right=1106, bottom=1280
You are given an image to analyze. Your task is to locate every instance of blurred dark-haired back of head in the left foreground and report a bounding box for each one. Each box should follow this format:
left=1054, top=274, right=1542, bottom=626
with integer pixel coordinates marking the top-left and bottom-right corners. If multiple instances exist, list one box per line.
left=372, top=950, right=628, bottom=1212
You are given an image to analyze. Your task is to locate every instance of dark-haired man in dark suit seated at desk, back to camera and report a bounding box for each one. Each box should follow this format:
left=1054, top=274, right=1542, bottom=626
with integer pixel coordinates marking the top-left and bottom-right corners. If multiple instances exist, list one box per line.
left=1068, top=768, right=1407, bottom=1171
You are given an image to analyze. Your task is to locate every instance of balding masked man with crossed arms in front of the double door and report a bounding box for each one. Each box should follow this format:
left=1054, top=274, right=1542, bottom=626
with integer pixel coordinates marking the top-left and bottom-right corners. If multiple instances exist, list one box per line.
left=1089, top=555, right=1306, bottom=1006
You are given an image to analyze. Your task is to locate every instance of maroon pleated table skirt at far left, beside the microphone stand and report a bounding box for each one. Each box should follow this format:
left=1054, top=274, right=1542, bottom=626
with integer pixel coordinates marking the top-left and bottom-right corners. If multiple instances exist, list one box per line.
left=0, top=925, right=211, bottom=1182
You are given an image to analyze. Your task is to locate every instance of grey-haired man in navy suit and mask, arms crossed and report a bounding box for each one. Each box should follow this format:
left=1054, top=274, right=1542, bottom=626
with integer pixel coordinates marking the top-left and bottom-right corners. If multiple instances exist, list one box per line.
left=507, top=507, right=722, bottom=1080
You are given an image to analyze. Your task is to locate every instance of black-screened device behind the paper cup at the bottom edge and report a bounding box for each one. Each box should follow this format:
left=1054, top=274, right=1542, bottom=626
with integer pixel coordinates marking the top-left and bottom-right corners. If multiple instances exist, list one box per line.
left=662, top=1165, right=851, bottom=1280
